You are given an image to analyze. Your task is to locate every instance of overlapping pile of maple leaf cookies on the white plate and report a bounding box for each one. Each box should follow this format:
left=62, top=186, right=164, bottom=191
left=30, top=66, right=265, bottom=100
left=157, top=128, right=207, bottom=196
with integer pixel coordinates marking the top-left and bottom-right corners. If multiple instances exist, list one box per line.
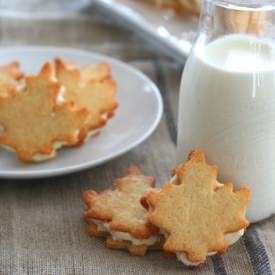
left=0, top=59, right=118, bottom=162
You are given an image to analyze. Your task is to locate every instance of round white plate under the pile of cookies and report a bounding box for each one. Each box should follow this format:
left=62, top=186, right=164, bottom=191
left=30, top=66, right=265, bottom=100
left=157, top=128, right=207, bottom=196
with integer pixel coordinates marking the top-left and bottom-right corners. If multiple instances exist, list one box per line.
left=0, top=47, right=163, bottom=179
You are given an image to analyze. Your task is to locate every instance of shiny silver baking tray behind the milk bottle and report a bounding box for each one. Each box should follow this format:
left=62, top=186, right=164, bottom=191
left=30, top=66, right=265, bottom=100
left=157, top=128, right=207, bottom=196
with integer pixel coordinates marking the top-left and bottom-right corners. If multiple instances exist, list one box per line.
left=92, top=0, right=198, bottom=60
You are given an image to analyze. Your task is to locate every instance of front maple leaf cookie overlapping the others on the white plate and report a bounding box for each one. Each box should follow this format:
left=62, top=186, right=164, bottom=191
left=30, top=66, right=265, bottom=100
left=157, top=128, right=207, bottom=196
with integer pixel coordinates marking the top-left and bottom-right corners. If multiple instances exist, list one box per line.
left=0, top=63, right=89, bottom=162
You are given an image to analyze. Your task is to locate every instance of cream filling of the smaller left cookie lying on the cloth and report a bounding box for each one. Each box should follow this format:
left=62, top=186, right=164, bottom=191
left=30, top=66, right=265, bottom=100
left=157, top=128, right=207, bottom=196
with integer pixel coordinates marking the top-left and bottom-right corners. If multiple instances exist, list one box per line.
left=91, top=219, right=160, bottom=246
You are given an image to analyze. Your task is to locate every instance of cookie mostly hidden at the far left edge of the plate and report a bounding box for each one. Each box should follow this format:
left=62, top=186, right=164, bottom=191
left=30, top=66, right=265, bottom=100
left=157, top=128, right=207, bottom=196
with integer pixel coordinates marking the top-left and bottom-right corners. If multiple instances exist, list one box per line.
left=0, top=61, right=23, bottom=96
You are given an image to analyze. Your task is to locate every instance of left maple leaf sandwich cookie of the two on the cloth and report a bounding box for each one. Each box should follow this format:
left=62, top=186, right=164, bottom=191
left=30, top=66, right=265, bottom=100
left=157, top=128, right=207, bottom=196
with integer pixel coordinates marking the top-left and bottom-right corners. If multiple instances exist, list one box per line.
left=84, top=166, right=161, bottom=255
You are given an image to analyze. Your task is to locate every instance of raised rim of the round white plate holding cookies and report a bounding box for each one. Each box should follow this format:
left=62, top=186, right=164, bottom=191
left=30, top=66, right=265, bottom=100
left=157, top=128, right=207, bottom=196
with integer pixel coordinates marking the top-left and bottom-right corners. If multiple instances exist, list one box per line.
left=0, top=45, right=164, bottom=180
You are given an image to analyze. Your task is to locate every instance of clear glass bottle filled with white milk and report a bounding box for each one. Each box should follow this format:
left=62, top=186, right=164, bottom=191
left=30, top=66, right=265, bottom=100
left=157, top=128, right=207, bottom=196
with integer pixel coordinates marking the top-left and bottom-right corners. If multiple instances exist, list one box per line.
left=177, top=0, right=275, bottom=222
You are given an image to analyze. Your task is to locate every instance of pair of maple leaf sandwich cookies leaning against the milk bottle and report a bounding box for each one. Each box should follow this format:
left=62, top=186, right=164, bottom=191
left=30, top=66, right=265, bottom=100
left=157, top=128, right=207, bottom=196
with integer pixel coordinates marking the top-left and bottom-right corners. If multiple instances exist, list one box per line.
left=84, top=150, right=251, bottom=266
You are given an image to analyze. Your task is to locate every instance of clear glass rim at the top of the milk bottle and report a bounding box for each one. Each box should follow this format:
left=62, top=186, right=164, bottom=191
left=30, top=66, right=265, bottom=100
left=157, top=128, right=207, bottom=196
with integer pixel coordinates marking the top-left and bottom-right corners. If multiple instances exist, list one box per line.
left=205, top=0, right=275, bottom=10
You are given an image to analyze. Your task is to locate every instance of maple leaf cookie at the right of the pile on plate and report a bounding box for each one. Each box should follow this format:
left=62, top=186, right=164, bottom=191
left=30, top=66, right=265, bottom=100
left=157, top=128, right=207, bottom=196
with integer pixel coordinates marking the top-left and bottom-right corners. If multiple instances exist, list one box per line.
left=55, top=59, right=118, bottom=131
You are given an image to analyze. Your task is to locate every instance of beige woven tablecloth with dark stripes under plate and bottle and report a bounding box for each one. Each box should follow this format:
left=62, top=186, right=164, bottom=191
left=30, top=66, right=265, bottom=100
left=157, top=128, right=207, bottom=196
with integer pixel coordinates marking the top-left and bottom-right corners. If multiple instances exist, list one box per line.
left=0, top=2, right=275, bottom=275
